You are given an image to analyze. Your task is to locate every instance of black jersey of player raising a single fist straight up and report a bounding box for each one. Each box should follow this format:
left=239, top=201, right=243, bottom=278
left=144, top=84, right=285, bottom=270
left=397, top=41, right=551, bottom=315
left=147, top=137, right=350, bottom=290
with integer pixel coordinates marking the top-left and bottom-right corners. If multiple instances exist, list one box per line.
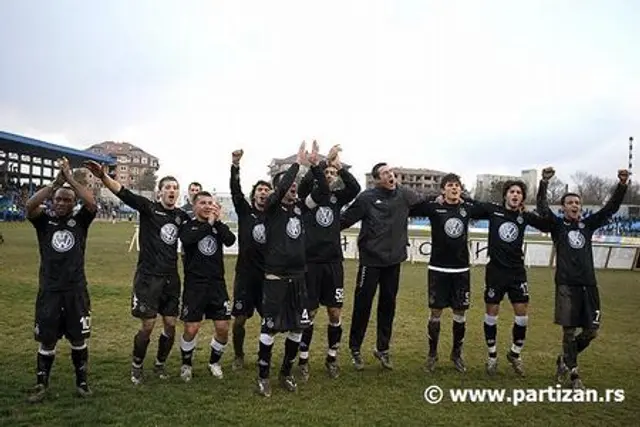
left=229, top=165, right=267, bottom=275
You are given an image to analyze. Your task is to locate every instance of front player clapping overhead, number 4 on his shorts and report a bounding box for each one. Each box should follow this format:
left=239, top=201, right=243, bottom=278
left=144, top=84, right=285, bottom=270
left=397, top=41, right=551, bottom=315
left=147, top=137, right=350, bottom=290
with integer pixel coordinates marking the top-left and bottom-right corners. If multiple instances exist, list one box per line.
left=257, top=141, right=329, bottom=397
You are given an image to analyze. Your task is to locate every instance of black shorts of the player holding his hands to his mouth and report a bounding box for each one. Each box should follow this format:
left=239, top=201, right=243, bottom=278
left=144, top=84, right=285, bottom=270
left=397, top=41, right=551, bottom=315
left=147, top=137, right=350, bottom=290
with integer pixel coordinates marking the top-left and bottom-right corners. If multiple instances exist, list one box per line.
left=180, top=282, right=231, bottom=322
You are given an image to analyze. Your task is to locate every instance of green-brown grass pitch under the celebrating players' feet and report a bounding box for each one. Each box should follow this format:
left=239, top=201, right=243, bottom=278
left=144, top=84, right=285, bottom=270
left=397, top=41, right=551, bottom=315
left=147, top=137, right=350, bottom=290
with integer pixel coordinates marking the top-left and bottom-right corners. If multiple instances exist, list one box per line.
left=0, top=223, right=640, bottom=427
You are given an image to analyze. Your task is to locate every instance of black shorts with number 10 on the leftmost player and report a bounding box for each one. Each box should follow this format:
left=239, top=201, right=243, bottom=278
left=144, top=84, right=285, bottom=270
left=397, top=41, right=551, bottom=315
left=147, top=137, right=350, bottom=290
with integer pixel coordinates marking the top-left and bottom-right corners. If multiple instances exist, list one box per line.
left=33, top=286, right=91, bottom=344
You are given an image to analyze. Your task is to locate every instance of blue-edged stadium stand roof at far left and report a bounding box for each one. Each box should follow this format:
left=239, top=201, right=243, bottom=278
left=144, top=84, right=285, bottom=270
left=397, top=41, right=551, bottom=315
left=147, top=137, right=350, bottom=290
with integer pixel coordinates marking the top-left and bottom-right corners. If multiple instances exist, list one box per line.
left=0, top=131, right=116, bottom=167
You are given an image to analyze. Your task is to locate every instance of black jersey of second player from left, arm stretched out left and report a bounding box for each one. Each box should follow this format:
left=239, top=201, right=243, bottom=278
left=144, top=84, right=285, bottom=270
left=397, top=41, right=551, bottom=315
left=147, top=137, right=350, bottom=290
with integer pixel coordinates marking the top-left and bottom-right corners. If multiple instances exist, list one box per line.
left=116, top=187, right=189, bottom=276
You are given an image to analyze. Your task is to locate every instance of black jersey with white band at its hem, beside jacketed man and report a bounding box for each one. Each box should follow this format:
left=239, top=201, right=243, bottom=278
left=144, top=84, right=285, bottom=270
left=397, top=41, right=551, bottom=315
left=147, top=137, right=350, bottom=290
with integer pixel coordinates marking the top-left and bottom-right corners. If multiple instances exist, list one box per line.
left=410, top=201, right=485, bottom=272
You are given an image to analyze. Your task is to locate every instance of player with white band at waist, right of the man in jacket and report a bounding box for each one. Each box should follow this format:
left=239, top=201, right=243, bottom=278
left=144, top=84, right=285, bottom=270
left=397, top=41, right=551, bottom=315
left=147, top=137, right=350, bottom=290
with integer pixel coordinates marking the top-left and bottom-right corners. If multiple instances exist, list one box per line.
left=410, top=173, right=484, bottom=372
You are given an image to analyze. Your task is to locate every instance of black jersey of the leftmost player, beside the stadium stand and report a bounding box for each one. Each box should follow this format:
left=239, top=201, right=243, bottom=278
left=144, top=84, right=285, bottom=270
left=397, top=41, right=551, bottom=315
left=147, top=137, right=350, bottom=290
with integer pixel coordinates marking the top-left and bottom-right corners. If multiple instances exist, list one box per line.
left=29, top=207, right=96, bottom=291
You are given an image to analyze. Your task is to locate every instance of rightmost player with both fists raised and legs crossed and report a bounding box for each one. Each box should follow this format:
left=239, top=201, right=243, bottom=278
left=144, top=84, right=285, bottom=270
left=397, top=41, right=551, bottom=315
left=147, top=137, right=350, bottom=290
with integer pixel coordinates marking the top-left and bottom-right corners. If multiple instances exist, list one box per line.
left=537, top=168, right=629, bottom=389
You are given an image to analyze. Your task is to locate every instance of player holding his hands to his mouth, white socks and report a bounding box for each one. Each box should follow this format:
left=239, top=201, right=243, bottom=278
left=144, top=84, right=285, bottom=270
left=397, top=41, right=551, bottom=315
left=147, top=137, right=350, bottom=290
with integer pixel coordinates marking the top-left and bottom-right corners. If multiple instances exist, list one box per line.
left=180, top=191, right=236, bottom=382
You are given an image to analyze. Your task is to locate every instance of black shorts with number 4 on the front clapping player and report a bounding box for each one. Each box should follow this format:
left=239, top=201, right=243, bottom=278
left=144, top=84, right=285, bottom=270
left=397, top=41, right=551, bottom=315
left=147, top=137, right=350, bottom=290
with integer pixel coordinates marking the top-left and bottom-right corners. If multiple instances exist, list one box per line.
left=261, top=275, right=311, bottom=333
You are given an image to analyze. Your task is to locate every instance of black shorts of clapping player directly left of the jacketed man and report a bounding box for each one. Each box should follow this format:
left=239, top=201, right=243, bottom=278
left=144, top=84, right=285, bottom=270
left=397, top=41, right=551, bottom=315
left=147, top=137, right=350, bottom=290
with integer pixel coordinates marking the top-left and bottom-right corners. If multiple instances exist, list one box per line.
left=306, top=262, right=344, bottom=310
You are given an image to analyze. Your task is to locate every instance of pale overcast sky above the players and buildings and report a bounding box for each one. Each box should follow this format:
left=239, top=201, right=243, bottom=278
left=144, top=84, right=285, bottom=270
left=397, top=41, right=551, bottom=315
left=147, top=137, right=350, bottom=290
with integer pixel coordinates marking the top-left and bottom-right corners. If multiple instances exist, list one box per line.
left=0, top=0, right=640, bottom=196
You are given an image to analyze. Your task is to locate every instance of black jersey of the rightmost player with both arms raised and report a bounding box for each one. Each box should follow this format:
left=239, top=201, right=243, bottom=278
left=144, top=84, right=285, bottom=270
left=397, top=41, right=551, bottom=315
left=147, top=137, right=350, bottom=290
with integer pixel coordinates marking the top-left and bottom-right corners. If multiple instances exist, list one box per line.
left=537, top=180, right=627, bottom=286
